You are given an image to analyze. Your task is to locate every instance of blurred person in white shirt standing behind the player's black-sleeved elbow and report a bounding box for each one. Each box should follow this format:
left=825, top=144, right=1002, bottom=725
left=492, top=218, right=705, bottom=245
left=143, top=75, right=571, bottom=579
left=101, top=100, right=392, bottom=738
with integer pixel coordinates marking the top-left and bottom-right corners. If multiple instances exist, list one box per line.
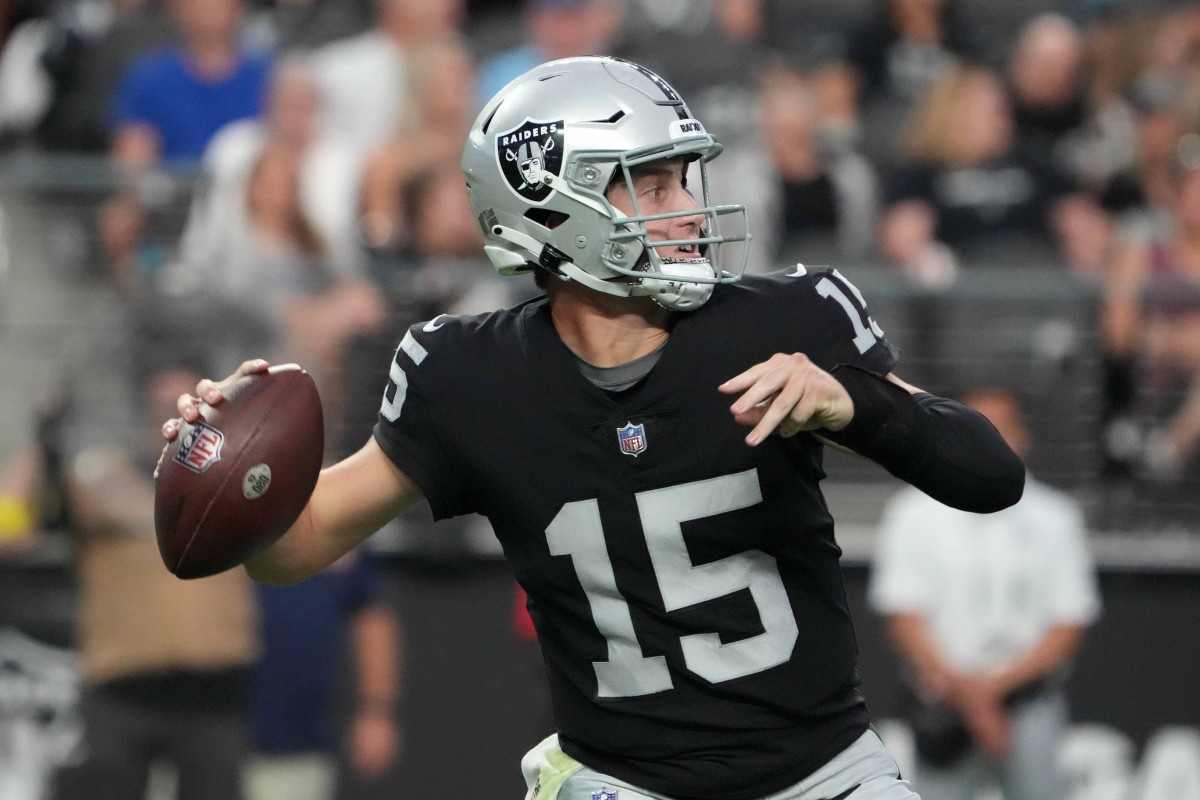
left=869, top=386, right=1100, bottom=800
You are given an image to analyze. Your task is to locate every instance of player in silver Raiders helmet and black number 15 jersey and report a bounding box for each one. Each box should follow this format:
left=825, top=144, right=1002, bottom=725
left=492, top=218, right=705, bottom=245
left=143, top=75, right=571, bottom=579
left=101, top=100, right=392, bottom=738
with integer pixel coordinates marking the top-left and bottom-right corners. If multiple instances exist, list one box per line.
left=164, top=58, right=1025, bottom=800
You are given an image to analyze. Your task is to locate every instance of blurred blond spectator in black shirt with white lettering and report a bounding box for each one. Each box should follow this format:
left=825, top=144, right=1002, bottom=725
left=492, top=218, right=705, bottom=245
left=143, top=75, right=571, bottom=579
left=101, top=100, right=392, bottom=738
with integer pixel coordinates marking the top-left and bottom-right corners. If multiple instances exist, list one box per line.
left=880, top=67, right=1108, bottom=287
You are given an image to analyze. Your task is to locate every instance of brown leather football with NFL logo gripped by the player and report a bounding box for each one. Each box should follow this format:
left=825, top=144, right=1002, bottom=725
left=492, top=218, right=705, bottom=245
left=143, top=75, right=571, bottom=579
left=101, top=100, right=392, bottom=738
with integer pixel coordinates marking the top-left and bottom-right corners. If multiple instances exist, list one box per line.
left=154, top=365, right=325, bottom=578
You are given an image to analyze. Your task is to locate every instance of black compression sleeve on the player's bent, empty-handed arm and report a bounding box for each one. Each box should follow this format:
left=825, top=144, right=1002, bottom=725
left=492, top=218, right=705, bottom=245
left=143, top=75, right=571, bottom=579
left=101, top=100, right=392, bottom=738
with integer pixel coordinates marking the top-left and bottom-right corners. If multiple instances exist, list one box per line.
left=821, top=363, right=1025, bottom=513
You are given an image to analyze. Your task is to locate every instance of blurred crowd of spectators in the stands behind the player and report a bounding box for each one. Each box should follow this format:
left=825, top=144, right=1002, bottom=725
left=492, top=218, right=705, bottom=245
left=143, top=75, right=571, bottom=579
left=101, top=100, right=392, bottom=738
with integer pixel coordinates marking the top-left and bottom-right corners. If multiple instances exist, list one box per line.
left=0, top=0, right=1200, bottom=491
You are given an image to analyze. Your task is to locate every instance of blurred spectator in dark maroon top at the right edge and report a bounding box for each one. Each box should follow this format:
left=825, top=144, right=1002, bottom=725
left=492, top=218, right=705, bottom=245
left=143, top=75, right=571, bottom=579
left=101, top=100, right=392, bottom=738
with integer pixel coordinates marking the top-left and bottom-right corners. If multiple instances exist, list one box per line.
left=1102, top=133, right=1200, bottom=476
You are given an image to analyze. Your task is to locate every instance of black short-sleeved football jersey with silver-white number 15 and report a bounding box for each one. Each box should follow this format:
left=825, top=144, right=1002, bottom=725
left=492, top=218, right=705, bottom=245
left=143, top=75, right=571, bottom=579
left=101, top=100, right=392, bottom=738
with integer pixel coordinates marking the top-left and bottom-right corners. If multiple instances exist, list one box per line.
left=374, top=266, right=895, bottom=800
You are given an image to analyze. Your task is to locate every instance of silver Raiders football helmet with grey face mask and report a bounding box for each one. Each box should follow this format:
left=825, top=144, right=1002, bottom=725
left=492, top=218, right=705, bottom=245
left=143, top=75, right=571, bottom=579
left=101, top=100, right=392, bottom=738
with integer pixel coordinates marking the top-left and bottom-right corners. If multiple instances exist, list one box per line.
left=462, top=56, right=749, bottom=311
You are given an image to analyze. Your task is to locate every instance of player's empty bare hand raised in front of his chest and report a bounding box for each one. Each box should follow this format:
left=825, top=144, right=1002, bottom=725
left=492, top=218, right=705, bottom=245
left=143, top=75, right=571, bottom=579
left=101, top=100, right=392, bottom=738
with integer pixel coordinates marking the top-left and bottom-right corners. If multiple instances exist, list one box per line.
left=718, top=353, right=854, bottom=447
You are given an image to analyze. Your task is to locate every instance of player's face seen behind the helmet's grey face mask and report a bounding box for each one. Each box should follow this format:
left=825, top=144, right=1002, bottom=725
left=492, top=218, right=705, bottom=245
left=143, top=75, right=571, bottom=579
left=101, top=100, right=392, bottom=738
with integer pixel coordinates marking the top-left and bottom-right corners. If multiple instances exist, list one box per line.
left=606, top=158, right=704, bottom=259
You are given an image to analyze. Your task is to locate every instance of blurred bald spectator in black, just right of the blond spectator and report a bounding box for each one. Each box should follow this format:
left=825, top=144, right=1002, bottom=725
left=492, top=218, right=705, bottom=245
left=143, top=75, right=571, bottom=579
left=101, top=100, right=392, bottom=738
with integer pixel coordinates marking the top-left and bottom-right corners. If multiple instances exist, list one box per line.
left=1007, top=13, right=1088, bottom=176
